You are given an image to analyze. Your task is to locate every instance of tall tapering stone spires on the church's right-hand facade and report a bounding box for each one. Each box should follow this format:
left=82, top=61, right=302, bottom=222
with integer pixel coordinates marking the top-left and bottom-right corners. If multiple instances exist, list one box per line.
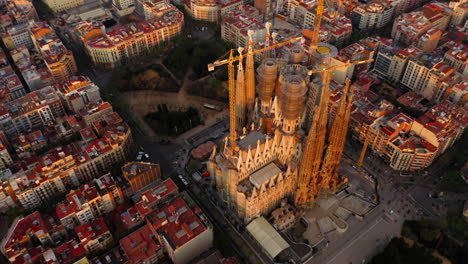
left=294, top=76, right=353, bottom=207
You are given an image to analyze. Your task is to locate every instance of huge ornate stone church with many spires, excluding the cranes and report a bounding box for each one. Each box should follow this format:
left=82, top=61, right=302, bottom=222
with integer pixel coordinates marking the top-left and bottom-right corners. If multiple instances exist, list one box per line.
left=207, top=28, right=353, bottom=223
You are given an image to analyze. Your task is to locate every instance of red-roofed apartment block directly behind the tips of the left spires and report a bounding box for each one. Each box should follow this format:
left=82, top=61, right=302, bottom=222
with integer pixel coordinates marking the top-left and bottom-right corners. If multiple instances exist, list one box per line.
left=221, top=5, right=266, bottom=48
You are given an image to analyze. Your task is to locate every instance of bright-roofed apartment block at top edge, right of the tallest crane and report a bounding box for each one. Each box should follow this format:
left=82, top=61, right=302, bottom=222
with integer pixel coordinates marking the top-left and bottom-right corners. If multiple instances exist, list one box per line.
left=351, top=1, right=394, bottom=30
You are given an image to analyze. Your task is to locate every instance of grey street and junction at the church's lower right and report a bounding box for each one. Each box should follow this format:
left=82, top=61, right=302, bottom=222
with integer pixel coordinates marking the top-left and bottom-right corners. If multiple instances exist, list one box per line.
left=306, top=141, right=452, bottom=264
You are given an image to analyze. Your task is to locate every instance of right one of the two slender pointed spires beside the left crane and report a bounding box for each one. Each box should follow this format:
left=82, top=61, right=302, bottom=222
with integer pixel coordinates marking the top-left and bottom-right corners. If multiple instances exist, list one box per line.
left=245, top=30, right=255, bottom=124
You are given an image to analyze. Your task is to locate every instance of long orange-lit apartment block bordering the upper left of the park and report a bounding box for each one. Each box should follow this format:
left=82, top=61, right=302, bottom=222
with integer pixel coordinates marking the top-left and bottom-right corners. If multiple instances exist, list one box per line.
left=85, top=5, right=184, bottom=68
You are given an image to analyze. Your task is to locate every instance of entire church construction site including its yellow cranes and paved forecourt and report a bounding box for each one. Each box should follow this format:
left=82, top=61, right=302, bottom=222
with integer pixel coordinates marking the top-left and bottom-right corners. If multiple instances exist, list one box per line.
left=203, top=1, right=374, bottom=261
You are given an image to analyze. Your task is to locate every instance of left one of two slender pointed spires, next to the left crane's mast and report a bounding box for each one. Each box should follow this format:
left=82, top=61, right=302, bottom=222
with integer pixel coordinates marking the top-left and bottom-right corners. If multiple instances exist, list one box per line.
left=236, top=47, right=246, bottom=135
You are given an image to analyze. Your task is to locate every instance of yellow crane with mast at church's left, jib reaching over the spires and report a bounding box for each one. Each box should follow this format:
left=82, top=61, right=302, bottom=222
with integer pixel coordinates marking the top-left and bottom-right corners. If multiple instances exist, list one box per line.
left=208, top=37, right=302, bottom=149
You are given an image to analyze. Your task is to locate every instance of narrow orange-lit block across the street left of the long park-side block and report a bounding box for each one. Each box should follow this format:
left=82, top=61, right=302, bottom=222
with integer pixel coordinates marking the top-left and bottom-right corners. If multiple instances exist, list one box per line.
left=30, top=22, right=78, bottom=82
